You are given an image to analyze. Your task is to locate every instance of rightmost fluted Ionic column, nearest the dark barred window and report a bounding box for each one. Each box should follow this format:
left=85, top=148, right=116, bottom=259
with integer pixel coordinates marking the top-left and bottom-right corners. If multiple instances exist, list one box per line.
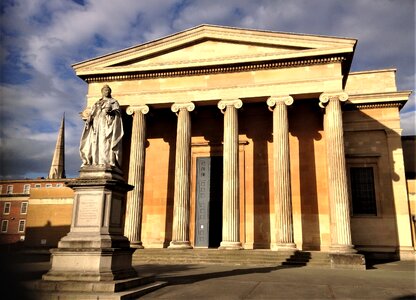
left=319, top=92, right=356, bottom=253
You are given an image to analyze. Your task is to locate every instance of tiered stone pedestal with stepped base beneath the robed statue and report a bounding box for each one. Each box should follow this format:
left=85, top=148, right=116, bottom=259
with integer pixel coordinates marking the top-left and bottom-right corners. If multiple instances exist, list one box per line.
left=33, top=166, right=165, bottom=299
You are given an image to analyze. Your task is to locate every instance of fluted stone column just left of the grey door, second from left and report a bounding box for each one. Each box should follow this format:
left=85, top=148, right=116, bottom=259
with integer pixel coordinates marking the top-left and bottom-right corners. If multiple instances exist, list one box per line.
left=169, top=102, right=195, bottom=249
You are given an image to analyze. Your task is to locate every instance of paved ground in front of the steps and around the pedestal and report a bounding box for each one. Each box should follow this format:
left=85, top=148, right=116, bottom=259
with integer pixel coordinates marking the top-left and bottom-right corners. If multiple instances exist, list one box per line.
left=0, top=254, right=416, bottom=300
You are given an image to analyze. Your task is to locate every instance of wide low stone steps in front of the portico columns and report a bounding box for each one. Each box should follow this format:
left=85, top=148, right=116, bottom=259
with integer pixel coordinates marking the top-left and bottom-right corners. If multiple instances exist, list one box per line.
left=133, top=249, right=331, bottom=268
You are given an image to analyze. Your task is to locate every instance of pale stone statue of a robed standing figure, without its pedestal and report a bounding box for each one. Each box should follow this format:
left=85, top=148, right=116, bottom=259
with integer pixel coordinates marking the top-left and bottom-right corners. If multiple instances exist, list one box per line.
left=79, top=85, right=124, bottom=168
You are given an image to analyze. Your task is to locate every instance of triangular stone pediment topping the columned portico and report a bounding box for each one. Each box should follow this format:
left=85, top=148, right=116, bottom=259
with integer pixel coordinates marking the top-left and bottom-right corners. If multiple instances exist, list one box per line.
left=73, top=25, right=356, bottom=77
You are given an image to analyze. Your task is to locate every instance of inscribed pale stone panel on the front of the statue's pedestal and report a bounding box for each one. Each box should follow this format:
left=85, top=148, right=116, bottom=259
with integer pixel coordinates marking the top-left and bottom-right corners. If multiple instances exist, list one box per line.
left=76, top=194, right=100, bottom=227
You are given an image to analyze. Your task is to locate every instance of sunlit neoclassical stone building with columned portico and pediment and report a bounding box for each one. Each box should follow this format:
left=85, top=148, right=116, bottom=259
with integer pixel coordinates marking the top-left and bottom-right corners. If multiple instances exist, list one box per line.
left=73, top=25, right=415, bottom=259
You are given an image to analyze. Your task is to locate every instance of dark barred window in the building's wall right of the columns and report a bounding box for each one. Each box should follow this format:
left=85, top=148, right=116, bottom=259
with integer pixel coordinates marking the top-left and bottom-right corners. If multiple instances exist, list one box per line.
left=349, top=166, right=377, bottom=216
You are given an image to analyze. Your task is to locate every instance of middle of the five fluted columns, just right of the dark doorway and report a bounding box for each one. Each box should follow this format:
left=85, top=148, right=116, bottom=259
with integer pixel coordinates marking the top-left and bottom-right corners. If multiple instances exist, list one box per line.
left=218, top=99, right=243, bottom=250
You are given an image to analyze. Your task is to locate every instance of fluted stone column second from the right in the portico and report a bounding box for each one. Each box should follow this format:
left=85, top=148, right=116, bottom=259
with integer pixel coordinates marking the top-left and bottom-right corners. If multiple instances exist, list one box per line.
left=267, top=96, right=296, bottom=251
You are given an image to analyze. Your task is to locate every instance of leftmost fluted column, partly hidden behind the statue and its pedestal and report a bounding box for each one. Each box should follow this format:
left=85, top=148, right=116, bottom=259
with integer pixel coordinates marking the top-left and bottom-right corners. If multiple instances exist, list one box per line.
left=124, top=105, right=149, bottom=249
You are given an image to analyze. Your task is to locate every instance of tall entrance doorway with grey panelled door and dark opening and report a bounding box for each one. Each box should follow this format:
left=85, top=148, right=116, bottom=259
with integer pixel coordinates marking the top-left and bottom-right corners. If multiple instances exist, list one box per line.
left=195, top=156, right=223, bottom=248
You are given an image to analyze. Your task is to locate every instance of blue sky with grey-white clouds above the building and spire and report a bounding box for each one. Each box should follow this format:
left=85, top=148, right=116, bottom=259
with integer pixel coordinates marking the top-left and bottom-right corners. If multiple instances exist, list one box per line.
left=0, top=0, right=416, bottom=179
